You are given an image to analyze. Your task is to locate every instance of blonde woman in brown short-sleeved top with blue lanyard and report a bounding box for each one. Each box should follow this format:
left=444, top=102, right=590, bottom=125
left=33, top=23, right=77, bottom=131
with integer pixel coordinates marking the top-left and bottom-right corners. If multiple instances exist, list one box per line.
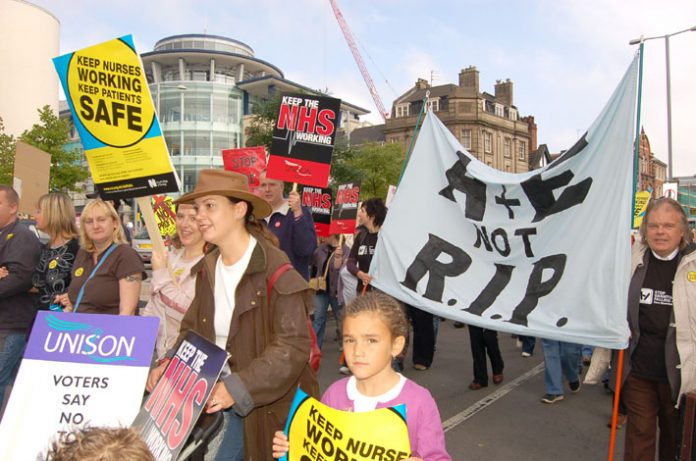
left=56, top=199, right=146, bottom=315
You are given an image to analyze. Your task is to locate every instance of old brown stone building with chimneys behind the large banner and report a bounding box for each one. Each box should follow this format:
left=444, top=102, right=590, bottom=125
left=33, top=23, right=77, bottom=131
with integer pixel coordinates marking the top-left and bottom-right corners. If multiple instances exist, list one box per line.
left=384, top=66, right=537, bottom=173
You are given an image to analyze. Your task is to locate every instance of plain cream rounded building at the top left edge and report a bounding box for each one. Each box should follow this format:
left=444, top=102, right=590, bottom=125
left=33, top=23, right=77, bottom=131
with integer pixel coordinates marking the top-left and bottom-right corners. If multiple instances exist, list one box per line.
left=0, top=0, right=60, bottom=136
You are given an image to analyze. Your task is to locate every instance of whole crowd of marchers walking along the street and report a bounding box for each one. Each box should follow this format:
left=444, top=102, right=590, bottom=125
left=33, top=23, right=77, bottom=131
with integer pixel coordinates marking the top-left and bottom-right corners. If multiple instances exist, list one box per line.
left=0, top=170, right=696, bottom=461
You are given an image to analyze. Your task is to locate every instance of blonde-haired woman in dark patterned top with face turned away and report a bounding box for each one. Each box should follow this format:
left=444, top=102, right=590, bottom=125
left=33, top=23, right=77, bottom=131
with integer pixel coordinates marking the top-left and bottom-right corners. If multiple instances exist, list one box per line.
left=32, top=192, right=80, bottom=310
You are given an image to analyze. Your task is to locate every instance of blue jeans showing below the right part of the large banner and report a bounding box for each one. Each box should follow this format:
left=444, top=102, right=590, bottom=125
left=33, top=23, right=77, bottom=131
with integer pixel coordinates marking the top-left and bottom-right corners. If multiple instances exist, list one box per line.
left=541, top=339, right=580, bottom=395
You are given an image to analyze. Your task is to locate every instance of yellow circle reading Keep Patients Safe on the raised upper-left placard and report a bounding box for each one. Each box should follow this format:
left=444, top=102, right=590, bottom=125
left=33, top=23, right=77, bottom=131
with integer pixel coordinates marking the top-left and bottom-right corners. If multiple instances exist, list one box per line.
left=67, top=39, right=155, bottom=147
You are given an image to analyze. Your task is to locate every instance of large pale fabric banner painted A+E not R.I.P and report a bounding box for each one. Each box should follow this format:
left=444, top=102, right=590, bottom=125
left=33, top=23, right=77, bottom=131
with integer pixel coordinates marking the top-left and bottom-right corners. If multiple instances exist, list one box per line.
left=370, top=54, right=638, bottom=349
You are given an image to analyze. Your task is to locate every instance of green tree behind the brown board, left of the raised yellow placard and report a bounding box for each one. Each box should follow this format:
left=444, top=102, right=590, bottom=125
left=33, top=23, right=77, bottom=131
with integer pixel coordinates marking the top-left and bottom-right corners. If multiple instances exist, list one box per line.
left=19, top=105, right=88, bottom=192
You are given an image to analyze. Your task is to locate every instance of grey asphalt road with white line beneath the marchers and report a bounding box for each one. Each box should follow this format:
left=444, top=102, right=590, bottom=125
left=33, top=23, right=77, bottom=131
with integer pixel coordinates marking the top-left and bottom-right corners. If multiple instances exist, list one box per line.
left=140, top=282, right=623, bottom=461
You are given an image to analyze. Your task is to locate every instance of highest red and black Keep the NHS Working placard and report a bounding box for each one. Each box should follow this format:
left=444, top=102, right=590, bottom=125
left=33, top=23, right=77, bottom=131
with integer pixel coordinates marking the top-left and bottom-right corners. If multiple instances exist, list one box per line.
left=266, top=93, right=341, bottom=187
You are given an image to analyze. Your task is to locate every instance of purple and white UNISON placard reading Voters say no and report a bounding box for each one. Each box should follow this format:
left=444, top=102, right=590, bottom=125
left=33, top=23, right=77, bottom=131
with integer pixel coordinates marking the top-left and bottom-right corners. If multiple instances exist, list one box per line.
left=0, top=311, right=158, bottom=460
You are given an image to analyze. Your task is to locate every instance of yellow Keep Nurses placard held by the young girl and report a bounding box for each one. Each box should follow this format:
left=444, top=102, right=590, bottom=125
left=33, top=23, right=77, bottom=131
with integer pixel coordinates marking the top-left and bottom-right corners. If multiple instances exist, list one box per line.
left=285, top=389, right=411, bottom=461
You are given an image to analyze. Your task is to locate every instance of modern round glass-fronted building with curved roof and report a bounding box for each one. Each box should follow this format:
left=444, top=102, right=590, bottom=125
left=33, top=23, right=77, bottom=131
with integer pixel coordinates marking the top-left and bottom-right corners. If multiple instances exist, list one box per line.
left=142, top=34, right=368, bottom=193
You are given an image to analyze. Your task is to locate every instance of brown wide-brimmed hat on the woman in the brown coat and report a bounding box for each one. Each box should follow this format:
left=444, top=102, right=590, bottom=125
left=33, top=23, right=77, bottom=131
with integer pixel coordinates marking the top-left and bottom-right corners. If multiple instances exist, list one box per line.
left=174, top=170, right=273, bottom=219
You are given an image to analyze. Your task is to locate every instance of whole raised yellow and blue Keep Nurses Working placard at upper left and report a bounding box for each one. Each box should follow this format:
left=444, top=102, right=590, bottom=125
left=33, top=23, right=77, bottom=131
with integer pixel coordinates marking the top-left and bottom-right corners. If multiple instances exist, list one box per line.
left=53, top=35, right=179, bottom=199
